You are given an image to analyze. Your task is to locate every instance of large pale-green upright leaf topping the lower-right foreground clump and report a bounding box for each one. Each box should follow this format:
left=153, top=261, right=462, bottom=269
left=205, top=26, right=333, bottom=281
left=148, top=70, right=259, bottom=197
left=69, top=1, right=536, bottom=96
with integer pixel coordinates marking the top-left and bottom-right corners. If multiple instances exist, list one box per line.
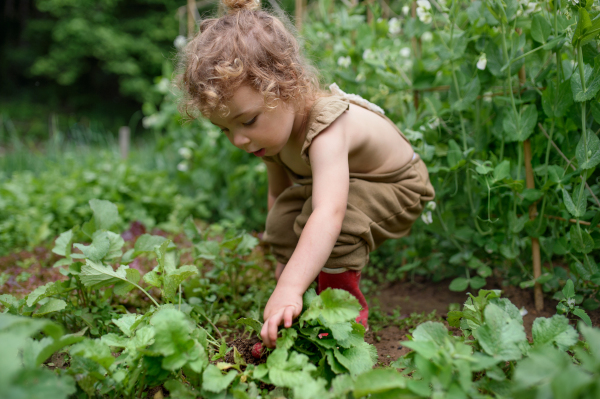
left=473, top=303, right=527, bottom=361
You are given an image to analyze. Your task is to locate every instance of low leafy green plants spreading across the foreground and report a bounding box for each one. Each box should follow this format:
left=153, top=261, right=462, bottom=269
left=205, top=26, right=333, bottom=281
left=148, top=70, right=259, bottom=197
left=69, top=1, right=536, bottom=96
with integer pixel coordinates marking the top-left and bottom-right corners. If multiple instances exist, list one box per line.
left=0, top=200, right=600, bottom=398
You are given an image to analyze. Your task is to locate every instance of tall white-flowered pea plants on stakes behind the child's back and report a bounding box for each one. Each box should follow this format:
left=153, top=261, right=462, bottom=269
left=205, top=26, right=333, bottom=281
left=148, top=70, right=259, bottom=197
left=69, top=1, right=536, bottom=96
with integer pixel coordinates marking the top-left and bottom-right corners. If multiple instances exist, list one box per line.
left=304, top=0, right=600, bottom=311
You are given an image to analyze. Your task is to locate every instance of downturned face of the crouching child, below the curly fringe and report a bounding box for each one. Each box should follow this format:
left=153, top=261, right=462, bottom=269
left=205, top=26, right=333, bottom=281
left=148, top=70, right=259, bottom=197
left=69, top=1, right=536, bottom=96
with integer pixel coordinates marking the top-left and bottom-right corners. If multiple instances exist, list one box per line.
left=210, top=85, right=300, bottom=157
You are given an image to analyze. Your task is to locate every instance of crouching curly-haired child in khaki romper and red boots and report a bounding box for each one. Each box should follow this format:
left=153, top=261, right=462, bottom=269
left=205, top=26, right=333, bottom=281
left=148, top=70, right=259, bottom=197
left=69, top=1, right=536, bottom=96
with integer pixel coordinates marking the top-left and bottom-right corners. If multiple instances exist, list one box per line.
left=176, top=0, right=434, bottom=348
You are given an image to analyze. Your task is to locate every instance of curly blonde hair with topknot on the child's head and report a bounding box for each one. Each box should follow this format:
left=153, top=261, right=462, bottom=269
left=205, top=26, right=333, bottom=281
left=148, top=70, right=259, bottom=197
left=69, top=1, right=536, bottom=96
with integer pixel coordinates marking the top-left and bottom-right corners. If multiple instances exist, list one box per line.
left=177, top=0, right=321, bottom=118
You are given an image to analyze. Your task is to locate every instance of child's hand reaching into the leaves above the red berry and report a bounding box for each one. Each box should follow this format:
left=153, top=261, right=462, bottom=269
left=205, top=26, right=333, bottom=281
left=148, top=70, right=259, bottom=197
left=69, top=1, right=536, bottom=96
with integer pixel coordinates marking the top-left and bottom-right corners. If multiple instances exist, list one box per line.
left=260, top=285, right=302, bottom=348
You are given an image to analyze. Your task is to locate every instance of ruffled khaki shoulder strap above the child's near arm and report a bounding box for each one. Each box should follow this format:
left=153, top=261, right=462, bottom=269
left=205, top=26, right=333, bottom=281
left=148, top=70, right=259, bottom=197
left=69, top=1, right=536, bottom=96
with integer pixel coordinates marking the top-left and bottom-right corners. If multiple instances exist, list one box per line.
left=300, top=95, right=350, bottom=165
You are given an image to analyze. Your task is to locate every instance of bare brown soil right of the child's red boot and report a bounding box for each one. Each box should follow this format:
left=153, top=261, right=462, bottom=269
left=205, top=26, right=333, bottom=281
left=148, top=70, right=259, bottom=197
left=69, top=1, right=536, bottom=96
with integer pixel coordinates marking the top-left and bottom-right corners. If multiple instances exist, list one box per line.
left=365, top=279, right=600, bottom=365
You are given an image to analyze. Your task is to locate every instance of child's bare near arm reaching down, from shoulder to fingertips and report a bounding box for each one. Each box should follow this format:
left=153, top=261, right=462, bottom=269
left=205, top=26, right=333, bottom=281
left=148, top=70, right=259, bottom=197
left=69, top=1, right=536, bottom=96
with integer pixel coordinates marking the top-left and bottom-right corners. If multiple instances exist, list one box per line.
left=261, top=125, right=350, bottom=348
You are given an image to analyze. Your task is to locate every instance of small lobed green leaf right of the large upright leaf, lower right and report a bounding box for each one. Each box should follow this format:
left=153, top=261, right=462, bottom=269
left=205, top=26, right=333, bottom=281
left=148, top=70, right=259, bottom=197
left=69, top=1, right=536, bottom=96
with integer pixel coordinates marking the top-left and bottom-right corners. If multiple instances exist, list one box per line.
left=531, top=315, right=579, bottom=351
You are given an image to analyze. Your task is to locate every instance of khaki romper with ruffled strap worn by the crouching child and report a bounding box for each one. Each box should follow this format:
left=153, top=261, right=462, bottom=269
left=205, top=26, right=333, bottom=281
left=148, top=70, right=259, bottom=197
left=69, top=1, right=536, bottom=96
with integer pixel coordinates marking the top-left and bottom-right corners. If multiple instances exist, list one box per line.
left=263, top=96, right=435, bottom=274
